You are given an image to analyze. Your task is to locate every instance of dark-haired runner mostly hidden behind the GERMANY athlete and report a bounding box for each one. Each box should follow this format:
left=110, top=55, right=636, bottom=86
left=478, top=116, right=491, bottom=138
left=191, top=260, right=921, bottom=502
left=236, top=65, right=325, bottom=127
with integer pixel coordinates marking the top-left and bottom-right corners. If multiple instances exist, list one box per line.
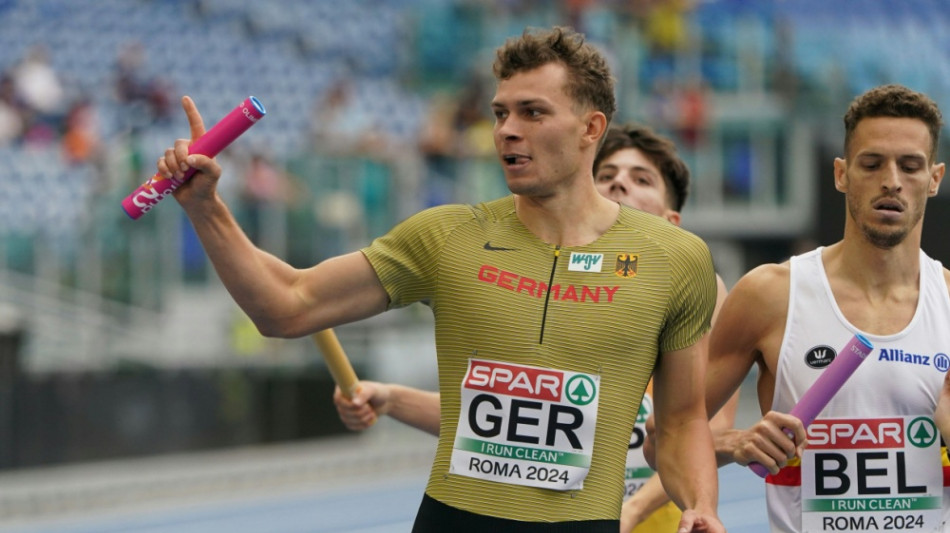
left=333, top=124, right=738, bottom=533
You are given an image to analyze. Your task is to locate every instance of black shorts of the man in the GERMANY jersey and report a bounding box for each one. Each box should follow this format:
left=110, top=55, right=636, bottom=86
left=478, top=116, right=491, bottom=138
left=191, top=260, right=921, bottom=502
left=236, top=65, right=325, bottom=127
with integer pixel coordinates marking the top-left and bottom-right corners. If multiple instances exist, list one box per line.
left=412, top=494, right=620, bottom=533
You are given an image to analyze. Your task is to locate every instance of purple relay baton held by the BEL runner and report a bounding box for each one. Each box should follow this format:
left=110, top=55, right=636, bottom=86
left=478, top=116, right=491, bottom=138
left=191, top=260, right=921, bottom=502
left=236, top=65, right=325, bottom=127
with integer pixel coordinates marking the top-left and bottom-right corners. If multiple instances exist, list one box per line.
left=749, top=334, right=874, bottom=478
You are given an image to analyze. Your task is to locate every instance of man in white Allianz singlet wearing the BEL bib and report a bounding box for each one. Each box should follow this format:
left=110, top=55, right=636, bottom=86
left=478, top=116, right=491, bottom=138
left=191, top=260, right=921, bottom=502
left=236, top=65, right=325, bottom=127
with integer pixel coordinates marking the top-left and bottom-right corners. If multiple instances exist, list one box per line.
left=706, top=85, right=950, bottom=532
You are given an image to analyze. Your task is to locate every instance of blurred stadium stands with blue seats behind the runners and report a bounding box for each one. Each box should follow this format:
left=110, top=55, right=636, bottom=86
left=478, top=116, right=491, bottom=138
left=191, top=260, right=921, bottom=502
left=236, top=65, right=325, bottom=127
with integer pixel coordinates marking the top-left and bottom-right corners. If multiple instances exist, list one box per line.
left=0, top=0, right=950, bottom=528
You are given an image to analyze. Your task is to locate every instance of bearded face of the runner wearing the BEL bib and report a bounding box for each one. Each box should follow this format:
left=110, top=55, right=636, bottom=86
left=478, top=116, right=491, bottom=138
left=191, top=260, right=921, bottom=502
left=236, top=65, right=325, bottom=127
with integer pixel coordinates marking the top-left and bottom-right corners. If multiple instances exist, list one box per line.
left=835, top=117, right=944, bottom=248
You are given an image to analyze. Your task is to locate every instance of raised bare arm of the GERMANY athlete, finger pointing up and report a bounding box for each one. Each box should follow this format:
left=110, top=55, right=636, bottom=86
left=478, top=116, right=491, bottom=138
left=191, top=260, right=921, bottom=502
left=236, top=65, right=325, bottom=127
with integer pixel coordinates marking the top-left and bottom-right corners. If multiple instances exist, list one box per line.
left=157, top=97, right=389, bottom=337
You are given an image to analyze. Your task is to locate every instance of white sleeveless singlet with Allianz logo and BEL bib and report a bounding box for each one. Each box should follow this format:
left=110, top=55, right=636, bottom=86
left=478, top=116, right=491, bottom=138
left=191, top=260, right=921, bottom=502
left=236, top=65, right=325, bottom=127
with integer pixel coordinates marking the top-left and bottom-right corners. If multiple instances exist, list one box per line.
left=766, top=248, right=950, bottom=533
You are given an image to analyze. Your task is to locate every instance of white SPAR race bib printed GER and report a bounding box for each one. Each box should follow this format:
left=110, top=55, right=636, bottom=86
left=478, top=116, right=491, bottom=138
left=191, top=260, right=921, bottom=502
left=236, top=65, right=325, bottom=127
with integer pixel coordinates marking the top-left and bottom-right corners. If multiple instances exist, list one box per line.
left=449, top=359, right=600, bottom=490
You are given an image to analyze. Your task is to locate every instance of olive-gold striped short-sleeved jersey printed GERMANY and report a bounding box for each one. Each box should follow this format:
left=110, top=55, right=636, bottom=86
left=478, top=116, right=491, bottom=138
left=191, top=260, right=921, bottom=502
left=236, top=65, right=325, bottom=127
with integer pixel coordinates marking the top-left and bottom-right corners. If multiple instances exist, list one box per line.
left=362, top=196, right=716, bottom=522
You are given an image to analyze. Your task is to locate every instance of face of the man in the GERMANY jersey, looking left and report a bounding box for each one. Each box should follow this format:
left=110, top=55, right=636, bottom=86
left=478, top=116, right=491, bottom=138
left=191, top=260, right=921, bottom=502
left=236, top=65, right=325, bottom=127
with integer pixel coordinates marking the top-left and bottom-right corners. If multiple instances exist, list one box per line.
left=491, top=63, right=591, bottom=197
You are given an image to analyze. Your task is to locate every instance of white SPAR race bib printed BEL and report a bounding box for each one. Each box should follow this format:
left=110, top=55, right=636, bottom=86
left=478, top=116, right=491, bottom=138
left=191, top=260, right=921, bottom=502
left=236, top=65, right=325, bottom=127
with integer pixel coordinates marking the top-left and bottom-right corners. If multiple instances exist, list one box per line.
left=801, top=416, right=943, bottom=532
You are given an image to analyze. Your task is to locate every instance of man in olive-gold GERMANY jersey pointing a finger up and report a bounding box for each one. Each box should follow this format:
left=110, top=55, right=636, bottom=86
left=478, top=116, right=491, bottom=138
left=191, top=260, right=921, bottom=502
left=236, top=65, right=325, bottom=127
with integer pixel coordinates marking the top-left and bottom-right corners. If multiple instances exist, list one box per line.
left=157, top=28, right=724, bottom=533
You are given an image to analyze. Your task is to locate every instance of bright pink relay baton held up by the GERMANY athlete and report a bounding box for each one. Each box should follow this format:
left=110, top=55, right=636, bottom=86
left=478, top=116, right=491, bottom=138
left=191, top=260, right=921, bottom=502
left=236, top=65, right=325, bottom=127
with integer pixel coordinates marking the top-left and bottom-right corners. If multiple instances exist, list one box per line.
left=122, top=96, right=267, bottom=220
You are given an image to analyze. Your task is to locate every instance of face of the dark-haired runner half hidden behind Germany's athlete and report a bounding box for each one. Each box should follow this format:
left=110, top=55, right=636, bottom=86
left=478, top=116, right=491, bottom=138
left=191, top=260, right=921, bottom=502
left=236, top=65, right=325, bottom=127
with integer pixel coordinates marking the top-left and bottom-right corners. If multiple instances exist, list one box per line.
left=594, top=148, right=679, bottom=224
